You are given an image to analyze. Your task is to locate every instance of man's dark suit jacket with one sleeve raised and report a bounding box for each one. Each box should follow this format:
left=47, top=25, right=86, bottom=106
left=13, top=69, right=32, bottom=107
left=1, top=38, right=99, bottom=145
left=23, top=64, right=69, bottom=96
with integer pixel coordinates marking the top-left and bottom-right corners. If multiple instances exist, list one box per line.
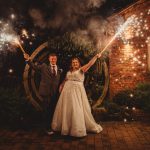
left=28, top=61, right=62, bottom=97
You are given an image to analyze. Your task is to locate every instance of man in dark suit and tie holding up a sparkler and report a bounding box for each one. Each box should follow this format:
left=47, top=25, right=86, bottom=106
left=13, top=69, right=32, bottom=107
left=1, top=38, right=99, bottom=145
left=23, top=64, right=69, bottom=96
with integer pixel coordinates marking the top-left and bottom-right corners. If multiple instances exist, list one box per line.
left=24, top=53, right=62, bottom=135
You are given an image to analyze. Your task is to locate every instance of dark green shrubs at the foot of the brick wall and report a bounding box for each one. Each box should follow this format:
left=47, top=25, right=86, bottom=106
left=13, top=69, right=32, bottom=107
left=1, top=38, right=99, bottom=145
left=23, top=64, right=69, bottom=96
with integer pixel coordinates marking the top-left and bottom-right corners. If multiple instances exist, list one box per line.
left=113, top=83, right=150, bottom=112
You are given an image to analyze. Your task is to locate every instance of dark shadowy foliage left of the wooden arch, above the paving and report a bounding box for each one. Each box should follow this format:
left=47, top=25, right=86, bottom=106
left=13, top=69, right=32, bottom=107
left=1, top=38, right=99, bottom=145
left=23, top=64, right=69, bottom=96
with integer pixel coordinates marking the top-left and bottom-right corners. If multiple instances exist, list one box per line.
left=0, top=87, right=40, bottom=128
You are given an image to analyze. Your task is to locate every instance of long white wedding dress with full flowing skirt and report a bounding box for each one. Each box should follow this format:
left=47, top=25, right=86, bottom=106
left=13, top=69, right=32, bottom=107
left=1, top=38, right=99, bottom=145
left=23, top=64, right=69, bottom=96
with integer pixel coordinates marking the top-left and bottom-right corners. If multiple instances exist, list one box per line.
left=52, top=69, right=102, bottom=137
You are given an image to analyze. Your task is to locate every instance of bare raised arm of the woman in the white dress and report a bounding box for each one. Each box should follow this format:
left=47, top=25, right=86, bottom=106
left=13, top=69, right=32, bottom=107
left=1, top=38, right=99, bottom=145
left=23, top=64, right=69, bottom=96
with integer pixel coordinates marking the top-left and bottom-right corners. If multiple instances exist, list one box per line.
left=81, top=53, right=101, bottom=72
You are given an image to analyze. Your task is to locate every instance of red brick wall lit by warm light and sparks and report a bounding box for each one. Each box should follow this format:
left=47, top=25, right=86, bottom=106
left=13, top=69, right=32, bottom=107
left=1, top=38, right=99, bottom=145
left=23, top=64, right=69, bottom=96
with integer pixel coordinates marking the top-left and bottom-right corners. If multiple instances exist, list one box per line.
left=109, top=0, right=150, bottom=98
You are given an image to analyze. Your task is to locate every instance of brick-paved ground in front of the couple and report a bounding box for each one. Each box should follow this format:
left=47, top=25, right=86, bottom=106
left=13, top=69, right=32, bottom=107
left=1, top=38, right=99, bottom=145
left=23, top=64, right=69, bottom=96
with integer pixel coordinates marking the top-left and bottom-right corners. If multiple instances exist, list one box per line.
left=0, top=122, right=150, bottom=150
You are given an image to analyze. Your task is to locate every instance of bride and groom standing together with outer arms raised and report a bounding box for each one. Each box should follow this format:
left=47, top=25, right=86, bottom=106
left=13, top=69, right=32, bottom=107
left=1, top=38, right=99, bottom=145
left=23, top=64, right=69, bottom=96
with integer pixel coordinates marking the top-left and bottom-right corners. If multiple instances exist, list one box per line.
left=24, top=51, right=102, bottom=137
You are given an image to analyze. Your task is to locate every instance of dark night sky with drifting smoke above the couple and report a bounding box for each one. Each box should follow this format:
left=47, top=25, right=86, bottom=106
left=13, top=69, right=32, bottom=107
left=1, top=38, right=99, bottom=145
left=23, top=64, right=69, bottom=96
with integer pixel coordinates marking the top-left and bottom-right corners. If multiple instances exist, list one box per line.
left=0, top=0, right=137, bottom=84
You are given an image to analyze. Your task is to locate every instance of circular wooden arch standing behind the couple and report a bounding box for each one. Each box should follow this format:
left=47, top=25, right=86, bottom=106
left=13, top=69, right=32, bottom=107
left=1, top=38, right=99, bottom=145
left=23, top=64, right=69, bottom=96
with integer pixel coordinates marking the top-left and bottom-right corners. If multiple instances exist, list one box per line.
left=23, top=42, right=109, bottom=111
